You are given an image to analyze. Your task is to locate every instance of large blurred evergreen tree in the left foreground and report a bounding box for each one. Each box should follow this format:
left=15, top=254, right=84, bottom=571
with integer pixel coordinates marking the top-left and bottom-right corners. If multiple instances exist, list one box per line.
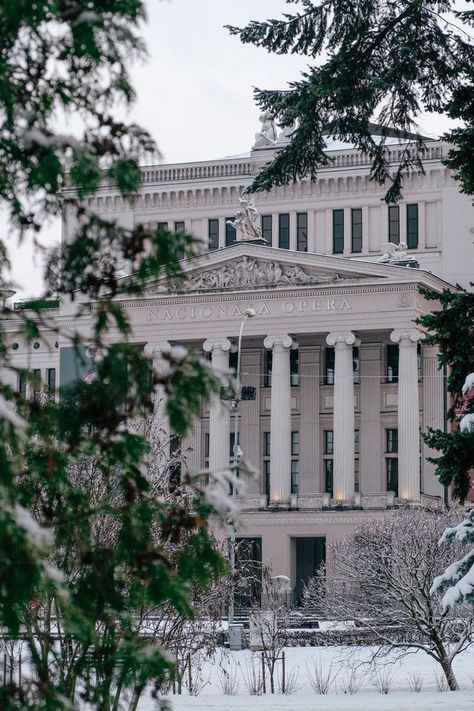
left=0, top=0, right=228, bottom=711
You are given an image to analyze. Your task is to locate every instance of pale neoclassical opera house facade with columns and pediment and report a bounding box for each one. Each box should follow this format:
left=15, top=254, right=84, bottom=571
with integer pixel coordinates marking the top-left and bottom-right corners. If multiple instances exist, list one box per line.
left=4, top=131, right=474, bottom=594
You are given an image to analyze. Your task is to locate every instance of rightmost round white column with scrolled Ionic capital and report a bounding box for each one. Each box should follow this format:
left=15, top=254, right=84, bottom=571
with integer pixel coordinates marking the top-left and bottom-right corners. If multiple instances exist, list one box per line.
left=390, top=328, right=421, bottom=501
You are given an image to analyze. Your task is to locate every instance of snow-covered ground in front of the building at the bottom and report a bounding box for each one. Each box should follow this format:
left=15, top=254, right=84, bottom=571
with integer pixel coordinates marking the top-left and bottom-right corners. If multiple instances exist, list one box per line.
left=139, top=647, right=474, bottom=711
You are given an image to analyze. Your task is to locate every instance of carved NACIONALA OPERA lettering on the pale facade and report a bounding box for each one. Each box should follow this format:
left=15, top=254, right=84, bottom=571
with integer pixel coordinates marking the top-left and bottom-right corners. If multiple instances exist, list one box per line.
left=146, top=297, right=352, bottom=321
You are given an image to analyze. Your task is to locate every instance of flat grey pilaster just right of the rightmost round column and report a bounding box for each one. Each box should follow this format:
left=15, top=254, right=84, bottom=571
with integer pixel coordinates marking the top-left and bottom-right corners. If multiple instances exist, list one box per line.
left=422, top=346, right=444, bottom=497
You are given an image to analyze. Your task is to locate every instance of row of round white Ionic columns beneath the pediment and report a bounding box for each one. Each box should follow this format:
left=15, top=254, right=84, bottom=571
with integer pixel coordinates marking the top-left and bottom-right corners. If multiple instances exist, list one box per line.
left=147, top=329, right=421, bottom=506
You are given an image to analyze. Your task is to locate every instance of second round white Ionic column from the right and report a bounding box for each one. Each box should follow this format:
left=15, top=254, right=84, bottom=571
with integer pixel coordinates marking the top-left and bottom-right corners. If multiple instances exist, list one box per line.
left=326, top=331, right=357, bottom=506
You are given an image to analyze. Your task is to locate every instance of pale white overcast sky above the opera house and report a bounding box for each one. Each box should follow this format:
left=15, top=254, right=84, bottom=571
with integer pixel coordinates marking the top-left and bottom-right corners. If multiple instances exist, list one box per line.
left=7, top=0, right=462, bottom=299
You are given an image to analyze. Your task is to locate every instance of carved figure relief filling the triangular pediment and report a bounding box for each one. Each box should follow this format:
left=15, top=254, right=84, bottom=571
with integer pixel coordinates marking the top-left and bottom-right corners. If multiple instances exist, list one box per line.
left=147, top=256, right=360, bottom=293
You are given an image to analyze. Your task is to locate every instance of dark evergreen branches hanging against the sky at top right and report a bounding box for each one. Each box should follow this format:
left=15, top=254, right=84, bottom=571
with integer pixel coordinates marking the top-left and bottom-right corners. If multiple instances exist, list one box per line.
left=228, top=0, right=474, bottom=202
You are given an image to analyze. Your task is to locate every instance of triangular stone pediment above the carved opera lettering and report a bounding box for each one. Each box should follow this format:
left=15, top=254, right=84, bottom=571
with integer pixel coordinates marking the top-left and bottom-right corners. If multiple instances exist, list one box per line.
left=145, top=243, right=434, bottom=294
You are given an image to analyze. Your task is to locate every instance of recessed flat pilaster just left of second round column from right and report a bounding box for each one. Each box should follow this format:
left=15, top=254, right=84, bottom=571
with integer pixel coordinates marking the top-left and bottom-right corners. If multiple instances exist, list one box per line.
left=299, top=346, right=323, bottom=494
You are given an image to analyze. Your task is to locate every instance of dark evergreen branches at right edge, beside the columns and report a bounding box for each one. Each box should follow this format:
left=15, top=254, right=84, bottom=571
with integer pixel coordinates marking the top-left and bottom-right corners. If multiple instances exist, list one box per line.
left=418, top=287, right=474, bottom=501
